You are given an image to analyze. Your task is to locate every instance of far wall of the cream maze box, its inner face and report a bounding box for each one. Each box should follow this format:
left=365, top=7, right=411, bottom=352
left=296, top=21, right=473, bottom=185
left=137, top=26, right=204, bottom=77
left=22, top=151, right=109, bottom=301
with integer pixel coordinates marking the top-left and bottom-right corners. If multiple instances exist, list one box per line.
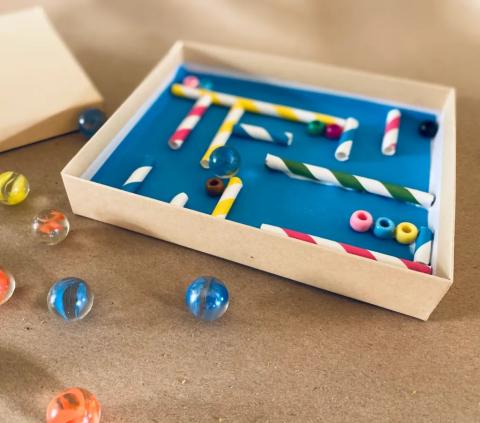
left=185, top=41, right=449, bottom=110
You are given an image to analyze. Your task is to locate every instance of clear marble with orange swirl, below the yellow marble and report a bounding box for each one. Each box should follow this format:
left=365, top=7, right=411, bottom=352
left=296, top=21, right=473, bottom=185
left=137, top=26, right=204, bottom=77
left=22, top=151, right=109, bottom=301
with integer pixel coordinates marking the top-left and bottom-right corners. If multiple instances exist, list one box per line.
left=32, top=209, right=70, bottom=245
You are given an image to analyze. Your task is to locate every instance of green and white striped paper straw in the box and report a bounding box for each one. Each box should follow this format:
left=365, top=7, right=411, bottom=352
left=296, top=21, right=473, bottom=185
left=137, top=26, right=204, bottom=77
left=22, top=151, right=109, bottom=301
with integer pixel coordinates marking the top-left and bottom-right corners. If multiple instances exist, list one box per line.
left=265, top=154, right=435, bottom=208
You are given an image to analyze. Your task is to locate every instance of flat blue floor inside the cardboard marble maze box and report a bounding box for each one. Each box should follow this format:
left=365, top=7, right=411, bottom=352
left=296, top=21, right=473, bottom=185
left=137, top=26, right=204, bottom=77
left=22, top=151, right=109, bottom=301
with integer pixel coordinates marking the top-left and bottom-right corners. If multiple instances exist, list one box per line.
left=92, top=67, right=435, bottom=259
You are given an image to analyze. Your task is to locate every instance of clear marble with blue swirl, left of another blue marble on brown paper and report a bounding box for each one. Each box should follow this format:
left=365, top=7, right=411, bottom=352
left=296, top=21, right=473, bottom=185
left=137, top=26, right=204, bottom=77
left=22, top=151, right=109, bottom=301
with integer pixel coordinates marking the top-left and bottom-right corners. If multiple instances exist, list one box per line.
left=47, top=277, right=93, bottom=321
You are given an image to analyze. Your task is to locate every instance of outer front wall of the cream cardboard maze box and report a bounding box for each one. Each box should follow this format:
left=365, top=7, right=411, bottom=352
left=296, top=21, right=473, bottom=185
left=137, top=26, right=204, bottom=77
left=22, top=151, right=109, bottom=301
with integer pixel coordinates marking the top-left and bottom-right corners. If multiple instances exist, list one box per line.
left=62, top=173, right=450, bottom=320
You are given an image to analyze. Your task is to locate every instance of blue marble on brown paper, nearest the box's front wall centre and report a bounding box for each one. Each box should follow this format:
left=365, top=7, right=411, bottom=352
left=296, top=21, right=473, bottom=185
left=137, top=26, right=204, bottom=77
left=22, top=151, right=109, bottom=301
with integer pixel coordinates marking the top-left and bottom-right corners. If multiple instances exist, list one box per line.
left=185, top=276, right=228, bottom=321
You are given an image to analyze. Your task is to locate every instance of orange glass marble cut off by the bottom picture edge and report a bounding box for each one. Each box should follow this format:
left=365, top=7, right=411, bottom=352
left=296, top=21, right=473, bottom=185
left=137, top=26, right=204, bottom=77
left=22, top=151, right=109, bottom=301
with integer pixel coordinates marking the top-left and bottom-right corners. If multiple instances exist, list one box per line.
left=47, top=388, right=101, bottom=423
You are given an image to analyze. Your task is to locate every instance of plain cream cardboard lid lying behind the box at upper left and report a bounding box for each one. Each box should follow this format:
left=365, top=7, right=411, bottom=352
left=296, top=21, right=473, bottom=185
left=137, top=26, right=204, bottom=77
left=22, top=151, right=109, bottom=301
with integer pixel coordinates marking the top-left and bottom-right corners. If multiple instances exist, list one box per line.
left=0, top=7, right=103, bottom=151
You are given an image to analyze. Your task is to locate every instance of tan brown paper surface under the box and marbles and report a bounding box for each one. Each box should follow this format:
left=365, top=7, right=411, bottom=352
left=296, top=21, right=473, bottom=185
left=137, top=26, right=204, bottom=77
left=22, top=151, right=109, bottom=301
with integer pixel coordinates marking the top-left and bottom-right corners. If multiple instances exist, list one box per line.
left=0, top=0, right=480, bottom=423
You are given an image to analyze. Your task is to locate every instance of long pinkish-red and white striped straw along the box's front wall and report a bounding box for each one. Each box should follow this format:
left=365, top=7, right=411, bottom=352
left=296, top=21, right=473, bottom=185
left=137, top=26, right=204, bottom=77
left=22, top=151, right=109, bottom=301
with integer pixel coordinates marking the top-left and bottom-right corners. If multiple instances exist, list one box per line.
left=260, top=224, right=432, bottom=274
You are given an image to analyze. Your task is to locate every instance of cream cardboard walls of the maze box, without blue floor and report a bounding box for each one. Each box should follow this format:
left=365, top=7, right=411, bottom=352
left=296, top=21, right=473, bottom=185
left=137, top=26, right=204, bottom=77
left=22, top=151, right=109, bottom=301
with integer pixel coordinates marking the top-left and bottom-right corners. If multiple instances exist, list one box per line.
left=62, top=42, right=455, bottom=320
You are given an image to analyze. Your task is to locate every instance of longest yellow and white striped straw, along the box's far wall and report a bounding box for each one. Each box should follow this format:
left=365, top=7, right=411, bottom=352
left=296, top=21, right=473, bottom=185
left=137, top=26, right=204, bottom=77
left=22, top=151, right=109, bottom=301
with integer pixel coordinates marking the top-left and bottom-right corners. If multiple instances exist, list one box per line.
left=172, top=84, right=345, bottom=128
